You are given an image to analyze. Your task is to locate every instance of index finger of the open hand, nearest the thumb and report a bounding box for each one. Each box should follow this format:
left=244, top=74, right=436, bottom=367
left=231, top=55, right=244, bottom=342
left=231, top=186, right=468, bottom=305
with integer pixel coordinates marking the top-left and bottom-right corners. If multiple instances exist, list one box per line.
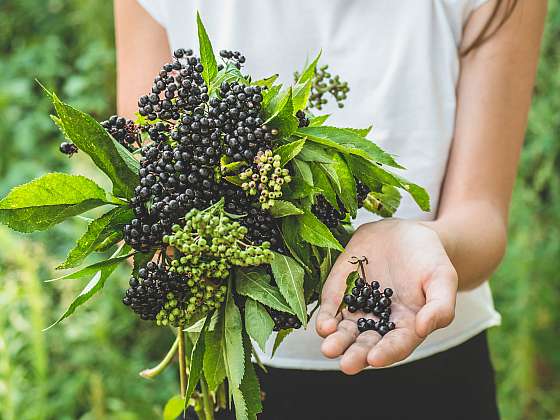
left=367, top=328, right=422, bottom=367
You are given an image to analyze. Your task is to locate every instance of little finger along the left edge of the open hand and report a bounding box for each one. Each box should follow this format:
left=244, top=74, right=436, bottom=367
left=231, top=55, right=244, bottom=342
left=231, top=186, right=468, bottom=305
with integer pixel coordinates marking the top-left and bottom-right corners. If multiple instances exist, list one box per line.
left=315, top=254, right=352, bottom=337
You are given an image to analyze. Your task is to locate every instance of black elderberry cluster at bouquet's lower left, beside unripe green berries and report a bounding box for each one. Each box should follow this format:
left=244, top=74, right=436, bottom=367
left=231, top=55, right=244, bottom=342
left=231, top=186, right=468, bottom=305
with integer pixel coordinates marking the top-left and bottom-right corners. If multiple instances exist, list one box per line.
left=123, top=262, right=189, bottom=325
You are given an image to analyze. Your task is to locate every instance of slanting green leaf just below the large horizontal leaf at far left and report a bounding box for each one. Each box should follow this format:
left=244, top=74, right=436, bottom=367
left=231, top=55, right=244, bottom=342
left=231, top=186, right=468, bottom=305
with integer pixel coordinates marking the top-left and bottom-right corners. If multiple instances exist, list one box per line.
left=56, top=207, right=134, bottom=270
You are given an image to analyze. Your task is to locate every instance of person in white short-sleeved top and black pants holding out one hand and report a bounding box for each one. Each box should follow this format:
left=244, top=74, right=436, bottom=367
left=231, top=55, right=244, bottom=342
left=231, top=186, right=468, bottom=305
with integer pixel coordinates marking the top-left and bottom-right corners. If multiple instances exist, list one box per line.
left=115, top=0, right=546, bottom=419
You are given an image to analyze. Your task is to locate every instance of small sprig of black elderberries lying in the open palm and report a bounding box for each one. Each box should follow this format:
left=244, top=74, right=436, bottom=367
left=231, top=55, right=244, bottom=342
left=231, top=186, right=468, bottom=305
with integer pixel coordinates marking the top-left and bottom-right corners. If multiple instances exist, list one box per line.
left=343, top=258, right=395, bottom=336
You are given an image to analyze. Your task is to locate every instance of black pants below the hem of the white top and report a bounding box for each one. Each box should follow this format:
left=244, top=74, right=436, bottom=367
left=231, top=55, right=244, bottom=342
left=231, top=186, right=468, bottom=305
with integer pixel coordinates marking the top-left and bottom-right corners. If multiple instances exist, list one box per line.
left=219, top=333, right=499, bottom=420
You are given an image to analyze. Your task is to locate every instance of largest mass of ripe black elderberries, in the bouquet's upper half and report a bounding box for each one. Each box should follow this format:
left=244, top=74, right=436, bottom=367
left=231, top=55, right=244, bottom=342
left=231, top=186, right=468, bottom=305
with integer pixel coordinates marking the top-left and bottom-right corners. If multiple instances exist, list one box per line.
left=124, top=49, right=279, bottom=252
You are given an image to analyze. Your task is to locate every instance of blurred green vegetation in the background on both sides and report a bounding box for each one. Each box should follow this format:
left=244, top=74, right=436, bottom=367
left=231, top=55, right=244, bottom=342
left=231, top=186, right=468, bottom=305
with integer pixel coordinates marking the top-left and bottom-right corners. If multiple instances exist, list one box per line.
left=0, top=0, right=560, bottom=420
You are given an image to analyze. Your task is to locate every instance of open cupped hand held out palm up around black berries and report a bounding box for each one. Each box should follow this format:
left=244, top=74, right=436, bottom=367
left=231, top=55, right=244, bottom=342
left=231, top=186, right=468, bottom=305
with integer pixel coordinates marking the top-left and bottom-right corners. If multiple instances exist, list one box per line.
left=316, top=219, right=457, bottom=374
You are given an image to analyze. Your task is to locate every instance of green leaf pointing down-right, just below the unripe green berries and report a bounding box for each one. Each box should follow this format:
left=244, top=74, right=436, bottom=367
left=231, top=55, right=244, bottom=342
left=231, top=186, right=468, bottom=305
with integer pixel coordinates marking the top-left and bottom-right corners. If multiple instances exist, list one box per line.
left=236, top=267, right=294, bottom=314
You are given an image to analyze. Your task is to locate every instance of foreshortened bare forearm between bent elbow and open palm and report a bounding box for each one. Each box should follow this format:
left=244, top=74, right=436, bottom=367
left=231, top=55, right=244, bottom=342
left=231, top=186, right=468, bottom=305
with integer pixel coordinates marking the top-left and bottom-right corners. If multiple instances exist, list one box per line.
left=424, top=200, right=507, bottom=290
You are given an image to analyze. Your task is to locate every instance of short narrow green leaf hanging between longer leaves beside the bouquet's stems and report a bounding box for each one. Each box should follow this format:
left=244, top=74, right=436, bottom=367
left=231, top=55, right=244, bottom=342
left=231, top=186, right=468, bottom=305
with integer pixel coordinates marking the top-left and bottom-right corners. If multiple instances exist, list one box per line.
left=203, top=311, right=226, bottom=392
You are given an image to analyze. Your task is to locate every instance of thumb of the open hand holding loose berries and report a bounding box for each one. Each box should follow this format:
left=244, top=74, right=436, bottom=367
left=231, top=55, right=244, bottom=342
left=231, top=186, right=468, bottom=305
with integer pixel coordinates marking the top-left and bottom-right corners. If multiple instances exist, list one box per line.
left=416, top=267, right=457, bottom=337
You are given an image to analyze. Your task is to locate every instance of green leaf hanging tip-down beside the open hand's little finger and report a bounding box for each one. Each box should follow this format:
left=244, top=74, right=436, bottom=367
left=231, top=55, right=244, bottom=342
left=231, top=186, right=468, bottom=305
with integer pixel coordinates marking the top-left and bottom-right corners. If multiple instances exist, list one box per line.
left=270, top=253, right=307, bottom=327
